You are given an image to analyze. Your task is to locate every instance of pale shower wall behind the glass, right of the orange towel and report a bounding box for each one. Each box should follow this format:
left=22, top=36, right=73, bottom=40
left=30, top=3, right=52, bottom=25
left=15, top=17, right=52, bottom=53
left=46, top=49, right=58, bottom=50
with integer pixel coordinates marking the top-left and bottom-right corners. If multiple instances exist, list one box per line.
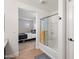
left=48, top=15, right=58, bottom=50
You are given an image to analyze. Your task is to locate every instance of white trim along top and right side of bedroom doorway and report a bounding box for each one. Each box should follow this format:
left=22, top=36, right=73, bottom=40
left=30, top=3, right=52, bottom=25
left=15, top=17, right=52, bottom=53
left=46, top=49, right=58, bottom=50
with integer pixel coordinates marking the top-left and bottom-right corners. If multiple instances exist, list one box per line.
left=17, top=2, right=38, bottom=49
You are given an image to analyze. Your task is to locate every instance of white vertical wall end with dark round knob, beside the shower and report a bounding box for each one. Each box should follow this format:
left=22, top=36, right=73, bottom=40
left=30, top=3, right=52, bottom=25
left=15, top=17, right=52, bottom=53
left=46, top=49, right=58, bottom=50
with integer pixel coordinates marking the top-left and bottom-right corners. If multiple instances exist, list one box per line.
left=58, top=0, right=66, bottom=59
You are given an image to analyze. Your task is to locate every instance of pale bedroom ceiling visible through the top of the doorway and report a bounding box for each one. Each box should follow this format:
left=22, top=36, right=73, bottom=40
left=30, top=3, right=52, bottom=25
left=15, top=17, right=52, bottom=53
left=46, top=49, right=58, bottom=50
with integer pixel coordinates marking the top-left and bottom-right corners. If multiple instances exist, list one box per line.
left=18, top=8, right=36, bottom=20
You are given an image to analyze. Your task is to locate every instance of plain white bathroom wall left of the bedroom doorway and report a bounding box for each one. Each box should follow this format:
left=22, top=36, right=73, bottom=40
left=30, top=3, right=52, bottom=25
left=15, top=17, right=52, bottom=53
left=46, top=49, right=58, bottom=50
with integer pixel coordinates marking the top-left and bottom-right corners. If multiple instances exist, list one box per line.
left=5, top=0, right=19, bottom=57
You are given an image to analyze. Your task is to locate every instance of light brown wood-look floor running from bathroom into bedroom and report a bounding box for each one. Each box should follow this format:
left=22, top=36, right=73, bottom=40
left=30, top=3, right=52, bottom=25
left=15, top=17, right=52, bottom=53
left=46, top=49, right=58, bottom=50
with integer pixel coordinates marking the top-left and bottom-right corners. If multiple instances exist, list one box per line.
left=13, top=40, right=43, bottom=59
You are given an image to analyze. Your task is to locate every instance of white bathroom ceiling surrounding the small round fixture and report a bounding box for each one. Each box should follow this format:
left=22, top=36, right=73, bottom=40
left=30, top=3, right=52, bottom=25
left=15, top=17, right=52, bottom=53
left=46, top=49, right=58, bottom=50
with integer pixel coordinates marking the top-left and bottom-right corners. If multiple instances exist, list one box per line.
left=18, top=0, right=58, bottom=11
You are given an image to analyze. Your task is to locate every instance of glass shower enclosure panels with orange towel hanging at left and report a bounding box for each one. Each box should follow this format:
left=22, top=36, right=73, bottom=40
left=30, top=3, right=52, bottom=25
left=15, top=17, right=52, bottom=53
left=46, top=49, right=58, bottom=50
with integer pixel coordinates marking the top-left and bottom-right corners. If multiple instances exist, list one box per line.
left=40, top=15, right=58, bottom=51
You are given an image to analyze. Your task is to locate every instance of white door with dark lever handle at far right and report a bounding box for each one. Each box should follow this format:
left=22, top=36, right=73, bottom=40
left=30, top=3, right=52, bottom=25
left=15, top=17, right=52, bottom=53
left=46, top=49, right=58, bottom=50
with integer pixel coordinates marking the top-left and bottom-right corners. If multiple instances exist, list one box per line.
left=67, top=0, right=74, bottom=59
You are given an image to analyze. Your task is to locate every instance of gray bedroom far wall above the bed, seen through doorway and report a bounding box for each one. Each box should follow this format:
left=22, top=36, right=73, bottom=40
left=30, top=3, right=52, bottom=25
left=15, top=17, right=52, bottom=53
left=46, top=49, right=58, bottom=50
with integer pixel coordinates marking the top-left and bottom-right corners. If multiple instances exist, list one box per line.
left=19, top=20, right=33, bottom=33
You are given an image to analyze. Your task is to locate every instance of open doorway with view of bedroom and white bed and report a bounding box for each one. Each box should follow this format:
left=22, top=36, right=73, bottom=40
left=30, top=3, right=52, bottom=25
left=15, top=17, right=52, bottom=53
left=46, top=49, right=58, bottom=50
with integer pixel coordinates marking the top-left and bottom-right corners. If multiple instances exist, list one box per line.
left=18, top=8, right=36, bottom=51
